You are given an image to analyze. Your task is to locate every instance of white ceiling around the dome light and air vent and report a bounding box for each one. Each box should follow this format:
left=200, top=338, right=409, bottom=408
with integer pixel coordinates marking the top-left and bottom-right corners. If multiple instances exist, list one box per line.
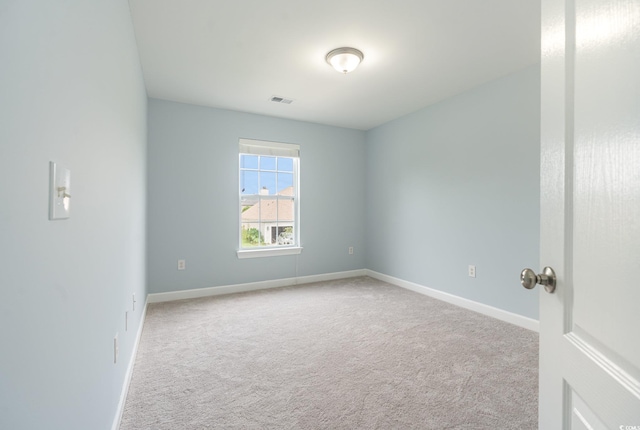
left=129, top=0, right=540, bottom=130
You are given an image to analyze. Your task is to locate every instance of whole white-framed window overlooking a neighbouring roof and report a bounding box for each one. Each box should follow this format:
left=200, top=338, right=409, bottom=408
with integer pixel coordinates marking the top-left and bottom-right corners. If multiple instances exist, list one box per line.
left=238, top=139, right=301, bottom=258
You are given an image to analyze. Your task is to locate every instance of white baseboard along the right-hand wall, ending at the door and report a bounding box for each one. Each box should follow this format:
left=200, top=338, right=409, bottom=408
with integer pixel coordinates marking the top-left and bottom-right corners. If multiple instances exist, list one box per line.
left=365, top=269, right=540, bottom=332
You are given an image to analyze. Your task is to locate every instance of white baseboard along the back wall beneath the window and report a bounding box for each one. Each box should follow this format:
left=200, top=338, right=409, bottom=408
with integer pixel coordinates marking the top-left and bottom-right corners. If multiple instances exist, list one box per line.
left=147, top=269, right=367, bottom=303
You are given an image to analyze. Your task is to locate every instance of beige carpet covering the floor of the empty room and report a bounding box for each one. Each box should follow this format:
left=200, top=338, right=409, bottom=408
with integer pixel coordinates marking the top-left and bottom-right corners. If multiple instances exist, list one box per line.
left=120, top=277, right=538, bottom=430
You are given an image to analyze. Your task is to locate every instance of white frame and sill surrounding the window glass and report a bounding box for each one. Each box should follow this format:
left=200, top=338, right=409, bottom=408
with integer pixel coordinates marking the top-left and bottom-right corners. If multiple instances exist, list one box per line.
left=236, top=139, right=302, bottom=259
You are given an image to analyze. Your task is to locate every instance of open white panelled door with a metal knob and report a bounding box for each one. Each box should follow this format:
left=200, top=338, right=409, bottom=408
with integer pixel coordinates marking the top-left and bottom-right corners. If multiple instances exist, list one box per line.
left=539, top=0, right=640, bottom=430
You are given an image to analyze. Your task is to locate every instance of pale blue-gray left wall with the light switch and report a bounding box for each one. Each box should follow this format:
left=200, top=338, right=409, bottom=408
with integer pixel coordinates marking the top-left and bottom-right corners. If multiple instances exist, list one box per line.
left=0, top=0, right=147, bottom=430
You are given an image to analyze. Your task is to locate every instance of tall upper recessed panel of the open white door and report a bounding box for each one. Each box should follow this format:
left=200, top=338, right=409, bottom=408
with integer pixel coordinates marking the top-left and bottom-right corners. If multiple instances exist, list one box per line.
left=573, top=0, right=640, bottom=377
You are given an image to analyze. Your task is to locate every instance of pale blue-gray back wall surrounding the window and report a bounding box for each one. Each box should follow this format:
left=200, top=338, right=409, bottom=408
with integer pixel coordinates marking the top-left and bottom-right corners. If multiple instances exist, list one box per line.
left=148, top=99, right=365, bottom=293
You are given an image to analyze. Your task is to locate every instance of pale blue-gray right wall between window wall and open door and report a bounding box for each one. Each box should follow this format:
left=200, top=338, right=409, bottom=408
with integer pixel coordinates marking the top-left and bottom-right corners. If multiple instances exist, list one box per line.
left=366, top=67, right=540, bottom=319
